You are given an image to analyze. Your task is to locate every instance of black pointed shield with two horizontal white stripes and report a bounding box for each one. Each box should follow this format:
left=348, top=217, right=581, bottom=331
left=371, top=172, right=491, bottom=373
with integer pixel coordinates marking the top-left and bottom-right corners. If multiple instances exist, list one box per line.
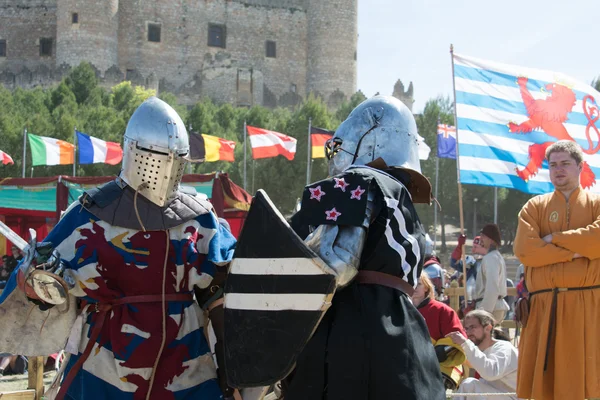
left=224, top=190, right=335, bottom=388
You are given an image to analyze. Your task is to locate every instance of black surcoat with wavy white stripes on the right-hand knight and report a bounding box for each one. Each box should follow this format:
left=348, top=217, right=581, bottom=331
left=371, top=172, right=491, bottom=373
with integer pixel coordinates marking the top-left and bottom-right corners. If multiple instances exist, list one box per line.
left=282, top=168, right=446, bottom=400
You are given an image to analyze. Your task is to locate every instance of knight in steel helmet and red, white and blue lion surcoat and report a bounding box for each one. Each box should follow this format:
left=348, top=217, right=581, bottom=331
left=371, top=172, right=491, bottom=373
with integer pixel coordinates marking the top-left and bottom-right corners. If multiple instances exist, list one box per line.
left=3, top=97, right=235, bottom=400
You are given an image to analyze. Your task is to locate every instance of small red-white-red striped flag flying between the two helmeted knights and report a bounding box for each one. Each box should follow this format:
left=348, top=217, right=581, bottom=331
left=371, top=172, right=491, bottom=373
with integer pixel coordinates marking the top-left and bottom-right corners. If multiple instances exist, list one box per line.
left=247, top=126, right=298, bottom=161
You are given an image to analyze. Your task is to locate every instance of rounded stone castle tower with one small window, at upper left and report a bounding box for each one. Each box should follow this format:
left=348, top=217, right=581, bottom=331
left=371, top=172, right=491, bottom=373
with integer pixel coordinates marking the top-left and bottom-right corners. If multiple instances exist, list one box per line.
left=56, top=0, right=119, bottom=74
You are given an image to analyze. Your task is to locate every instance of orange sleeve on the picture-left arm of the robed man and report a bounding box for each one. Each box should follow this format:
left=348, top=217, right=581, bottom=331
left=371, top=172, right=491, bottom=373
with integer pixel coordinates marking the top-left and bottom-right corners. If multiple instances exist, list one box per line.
left=513, top=198, right=581, bottom=267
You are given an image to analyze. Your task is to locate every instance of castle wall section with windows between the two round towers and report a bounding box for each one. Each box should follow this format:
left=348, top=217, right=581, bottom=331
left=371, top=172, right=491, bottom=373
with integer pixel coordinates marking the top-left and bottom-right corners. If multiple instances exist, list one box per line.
left=119, top=0, right=306, bottom=104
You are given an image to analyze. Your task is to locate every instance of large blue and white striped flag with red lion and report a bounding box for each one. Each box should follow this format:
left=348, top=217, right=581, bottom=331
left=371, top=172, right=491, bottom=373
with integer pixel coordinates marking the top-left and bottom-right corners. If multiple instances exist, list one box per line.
left=454, top=54, right=600, bottom=193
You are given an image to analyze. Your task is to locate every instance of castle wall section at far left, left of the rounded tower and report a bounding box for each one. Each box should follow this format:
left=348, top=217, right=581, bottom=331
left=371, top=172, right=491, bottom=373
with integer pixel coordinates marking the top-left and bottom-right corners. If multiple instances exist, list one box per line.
left=0, top=0, right=56, bottom=72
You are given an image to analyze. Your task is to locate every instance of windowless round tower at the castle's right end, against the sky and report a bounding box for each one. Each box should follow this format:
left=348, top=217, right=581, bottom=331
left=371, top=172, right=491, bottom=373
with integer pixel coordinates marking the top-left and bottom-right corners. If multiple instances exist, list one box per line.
left=306, top=0, right=358, bottom=101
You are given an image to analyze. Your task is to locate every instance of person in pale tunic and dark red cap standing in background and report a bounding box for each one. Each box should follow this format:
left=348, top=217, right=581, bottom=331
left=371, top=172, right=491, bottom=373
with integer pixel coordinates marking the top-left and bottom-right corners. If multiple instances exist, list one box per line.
left=475, top=224, right=510, bottom=322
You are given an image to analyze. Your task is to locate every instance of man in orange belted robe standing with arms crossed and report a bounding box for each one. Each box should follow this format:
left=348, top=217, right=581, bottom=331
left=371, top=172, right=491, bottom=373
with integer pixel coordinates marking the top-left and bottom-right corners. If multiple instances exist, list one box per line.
left=514, top=141, right=600, bottom=400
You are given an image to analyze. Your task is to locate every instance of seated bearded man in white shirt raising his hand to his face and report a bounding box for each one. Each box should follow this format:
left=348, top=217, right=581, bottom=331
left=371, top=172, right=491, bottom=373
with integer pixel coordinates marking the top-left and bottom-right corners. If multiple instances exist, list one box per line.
left=446, top=310, right=518, bottom=400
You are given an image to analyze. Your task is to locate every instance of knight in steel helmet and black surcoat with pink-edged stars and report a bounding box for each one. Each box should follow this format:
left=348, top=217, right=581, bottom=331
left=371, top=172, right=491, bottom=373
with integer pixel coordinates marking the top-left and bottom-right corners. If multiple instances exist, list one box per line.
left=283, top=96, right=445, bottom=400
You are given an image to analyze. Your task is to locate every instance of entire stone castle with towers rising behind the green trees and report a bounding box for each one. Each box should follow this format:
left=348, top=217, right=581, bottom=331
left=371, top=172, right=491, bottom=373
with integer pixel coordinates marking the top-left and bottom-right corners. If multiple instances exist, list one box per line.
left=0, top=0, right=356, bottom=108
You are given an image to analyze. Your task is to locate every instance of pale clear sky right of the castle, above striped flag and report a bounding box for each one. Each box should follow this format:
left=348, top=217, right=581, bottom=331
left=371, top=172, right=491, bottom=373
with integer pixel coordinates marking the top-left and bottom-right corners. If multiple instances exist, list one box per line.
left=357, top=0, right=600, bottom=113
